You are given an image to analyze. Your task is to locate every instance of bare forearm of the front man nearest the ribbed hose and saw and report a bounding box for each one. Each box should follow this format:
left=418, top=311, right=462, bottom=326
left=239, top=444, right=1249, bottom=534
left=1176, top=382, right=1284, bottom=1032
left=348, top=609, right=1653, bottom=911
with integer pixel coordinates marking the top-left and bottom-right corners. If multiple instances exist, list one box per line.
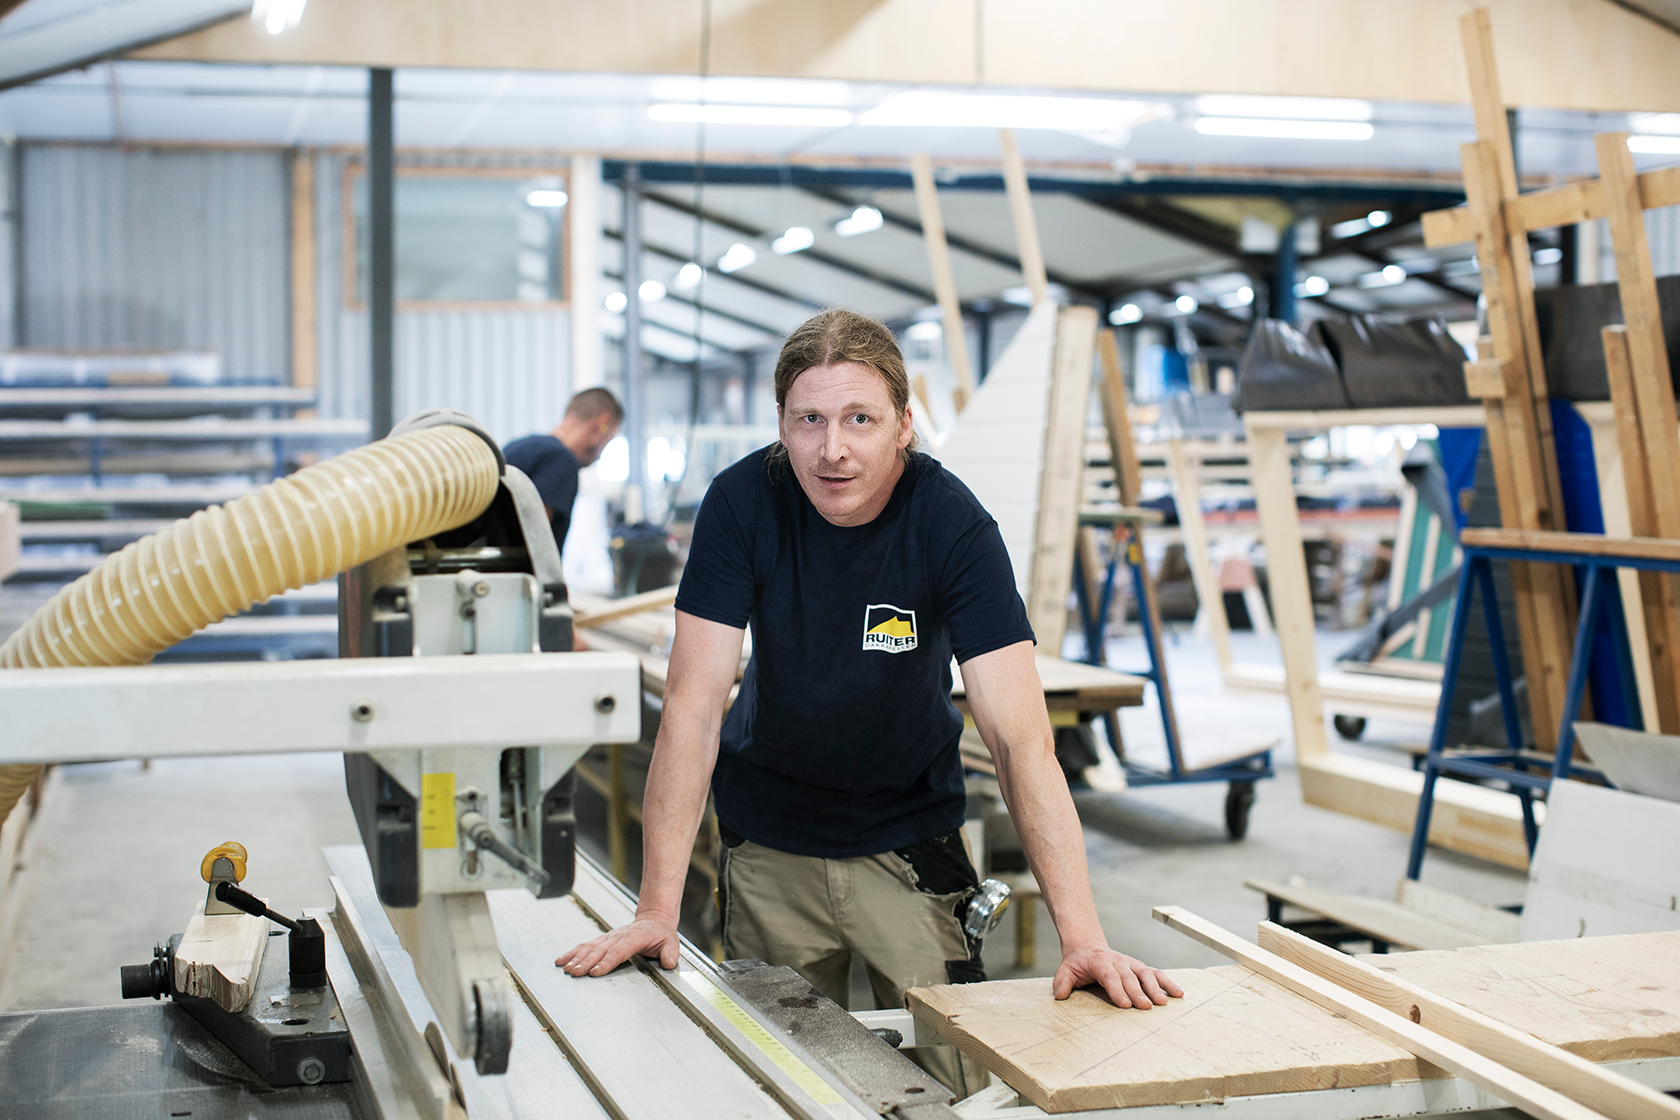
left=637, top=709, right=717, bottom=925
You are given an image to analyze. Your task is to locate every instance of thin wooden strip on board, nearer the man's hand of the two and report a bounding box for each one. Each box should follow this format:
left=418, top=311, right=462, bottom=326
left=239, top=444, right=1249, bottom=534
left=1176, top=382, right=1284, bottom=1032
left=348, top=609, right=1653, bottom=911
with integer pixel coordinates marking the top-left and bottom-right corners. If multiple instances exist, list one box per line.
left=1154, top=907, right=1603, bottom=1120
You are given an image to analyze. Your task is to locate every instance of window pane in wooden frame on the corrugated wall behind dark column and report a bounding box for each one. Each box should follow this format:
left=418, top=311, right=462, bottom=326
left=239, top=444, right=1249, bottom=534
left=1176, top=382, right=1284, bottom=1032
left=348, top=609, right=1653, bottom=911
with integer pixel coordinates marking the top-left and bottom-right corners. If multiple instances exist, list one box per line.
left=354, top=171, right=566, bottom=304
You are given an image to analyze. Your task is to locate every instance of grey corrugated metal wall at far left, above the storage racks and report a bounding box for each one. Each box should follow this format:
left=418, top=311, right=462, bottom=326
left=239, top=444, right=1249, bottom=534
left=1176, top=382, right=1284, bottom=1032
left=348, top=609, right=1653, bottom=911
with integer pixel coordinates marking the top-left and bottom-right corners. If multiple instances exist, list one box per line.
left=17, top=144, right=291, bottom=381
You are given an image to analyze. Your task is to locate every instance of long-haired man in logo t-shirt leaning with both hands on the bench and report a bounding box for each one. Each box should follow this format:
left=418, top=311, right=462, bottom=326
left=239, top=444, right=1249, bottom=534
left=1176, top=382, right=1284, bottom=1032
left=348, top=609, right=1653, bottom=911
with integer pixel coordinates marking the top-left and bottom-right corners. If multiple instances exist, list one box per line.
left=554, top=311, right=1183, bottom=1095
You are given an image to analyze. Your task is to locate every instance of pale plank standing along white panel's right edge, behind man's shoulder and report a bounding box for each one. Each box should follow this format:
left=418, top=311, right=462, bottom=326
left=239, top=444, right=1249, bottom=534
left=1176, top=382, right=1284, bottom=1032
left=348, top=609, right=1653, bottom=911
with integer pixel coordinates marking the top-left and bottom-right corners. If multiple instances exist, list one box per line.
left=1026, top=307, right=1097, bottom=653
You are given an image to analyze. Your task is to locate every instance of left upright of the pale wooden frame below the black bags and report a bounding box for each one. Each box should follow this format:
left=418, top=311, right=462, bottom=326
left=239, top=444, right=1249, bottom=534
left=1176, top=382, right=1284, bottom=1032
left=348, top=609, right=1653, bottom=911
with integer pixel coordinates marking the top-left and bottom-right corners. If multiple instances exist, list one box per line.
left=1249, top=416, right=1331, bottom=761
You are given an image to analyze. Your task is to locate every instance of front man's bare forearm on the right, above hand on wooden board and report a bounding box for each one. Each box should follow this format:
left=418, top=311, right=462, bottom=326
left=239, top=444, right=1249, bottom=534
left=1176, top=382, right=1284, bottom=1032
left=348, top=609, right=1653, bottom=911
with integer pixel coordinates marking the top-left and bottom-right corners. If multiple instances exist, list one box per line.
left=996, top=729, right=1107, bottom=954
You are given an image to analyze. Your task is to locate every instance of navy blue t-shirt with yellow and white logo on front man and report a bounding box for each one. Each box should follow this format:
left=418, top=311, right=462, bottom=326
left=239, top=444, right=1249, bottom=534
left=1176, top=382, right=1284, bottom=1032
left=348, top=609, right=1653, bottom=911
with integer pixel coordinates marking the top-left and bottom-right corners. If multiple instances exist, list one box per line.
left=677, top=448, right=1033, bottom=858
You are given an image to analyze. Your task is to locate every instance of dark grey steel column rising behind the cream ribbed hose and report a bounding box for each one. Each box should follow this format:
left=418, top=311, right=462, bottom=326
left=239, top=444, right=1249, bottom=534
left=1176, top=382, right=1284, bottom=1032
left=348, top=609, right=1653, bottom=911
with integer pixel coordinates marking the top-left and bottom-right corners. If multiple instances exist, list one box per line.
left=368, top=69, right=396, bottom=440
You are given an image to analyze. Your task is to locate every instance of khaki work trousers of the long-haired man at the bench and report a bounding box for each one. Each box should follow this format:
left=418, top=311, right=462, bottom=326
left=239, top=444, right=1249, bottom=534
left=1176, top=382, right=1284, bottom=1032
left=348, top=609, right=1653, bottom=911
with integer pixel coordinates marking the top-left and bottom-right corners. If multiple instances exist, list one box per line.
left=717, top=840, right=990, bottom=1100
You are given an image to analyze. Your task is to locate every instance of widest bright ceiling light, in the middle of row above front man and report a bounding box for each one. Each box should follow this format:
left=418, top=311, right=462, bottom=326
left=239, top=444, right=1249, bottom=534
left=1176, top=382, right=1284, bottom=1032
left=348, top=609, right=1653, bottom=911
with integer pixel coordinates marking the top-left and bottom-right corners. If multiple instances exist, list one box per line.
left=857, top=89, right=1166, bottom=133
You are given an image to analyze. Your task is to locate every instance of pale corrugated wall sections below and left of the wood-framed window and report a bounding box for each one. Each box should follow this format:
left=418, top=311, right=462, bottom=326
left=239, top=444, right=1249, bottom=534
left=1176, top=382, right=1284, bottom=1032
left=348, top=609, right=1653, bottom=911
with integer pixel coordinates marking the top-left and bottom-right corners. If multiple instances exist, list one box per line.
left=316, top=154, right=571, bottom=442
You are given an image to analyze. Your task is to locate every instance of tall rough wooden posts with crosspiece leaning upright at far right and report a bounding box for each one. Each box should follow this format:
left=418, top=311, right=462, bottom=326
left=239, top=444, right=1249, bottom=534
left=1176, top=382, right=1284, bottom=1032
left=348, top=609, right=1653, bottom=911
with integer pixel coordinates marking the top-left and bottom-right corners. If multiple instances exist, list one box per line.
left=1423, top=8, right=1680, bottom=749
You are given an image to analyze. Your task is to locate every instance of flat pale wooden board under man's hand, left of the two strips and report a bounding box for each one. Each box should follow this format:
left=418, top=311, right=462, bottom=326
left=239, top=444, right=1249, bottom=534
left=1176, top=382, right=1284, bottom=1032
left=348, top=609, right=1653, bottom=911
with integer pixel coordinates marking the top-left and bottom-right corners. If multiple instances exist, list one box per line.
left=906, top=966, right=1441, bottom=1112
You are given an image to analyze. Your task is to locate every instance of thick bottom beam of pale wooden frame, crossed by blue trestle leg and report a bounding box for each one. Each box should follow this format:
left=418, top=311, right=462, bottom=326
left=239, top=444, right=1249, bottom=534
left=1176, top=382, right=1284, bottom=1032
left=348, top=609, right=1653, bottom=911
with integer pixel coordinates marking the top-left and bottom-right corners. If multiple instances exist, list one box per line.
left=1300, top=752, right=1546, bottom=870
